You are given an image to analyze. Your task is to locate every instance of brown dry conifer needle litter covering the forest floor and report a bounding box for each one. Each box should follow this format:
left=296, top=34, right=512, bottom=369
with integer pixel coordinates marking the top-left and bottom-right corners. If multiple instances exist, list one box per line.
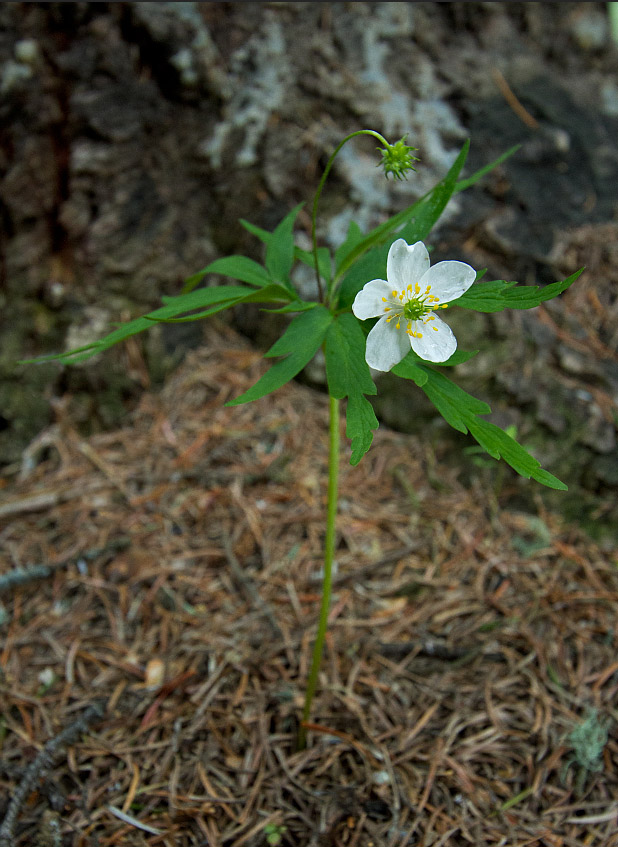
left=0, top=325, right=618, bottom=847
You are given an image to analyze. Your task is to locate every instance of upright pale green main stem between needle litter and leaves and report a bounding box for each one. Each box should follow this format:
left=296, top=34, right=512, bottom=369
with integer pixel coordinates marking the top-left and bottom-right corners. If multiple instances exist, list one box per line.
left=298, top=397, right=340, bottom=750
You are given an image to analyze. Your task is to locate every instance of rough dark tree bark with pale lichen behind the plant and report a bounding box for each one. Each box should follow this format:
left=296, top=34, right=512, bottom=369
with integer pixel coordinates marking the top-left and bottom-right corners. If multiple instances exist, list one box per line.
left=0, top=2, right=618, bottom=538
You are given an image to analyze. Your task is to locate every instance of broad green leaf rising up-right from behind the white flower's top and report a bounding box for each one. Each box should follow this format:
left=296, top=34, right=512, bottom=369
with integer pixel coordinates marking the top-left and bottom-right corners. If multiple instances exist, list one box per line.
left=335, top=141, right=470, bottom=308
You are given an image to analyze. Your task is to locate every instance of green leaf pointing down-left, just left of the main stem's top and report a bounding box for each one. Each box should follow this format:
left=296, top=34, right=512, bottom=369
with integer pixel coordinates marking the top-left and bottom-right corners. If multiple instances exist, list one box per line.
left=225, top=306, right=333, bottom=406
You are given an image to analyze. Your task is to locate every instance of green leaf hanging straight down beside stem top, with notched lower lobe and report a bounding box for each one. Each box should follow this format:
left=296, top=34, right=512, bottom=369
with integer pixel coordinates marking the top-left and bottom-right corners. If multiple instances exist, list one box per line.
left=324, top=312, right=378, bottom=465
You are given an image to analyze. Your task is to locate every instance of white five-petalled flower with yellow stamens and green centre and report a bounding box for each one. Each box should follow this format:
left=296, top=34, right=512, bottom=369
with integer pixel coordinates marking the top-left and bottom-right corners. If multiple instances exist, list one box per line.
left=352, top=238, right=476, bottom=371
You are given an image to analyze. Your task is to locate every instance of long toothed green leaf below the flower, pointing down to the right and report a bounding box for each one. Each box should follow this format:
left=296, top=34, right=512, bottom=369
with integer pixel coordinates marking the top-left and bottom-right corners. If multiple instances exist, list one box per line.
left=393, top=359, right=567, bottom=491
